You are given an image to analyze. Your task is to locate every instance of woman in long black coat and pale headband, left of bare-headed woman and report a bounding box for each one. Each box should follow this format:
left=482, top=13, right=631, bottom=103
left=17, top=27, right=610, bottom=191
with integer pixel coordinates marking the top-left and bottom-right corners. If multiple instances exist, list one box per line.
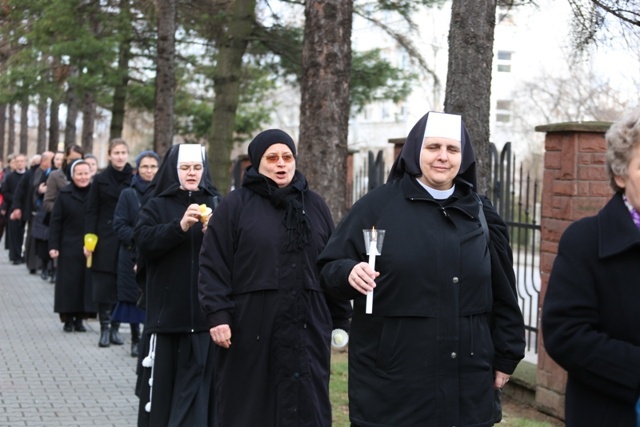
left=48, top=160, right=95, bottom=332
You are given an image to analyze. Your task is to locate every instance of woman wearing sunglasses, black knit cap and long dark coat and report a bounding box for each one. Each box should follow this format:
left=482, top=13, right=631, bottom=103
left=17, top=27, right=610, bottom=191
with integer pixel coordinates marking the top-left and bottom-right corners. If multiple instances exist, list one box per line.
left=199, top=129, right=351, bottom=427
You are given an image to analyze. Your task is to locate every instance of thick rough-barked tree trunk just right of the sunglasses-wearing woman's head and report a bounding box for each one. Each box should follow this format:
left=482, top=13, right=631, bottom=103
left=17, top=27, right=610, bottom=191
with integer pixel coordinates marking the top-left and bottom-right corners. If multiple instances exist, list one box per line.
left=297, top=0, right=352, bottom=225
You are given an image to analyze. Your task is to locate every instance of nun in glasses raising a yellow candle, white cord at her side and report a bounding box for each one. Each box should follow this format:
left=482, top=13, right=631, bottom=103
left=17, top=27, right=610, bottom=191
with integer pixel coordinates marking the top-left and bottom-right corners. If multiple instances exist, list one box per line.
left=134, top=144, right=220, bottom=427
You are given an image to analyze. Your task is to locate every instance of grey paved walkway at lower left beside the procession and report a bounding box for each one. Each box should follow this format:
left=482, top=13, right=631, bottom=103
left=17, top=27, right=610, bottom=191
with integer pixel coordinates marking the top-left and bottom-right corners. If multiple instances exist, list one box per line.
left=0, top=252, right=138, bottom=427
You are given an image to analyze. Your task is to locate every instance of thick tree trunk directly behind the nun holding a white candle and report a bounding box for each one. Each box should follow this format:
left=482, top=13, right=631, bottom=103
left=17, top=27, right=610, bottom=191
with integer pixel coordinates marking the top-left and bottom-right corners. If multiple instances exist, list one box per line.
left=444, top=0, right=496, bottom=194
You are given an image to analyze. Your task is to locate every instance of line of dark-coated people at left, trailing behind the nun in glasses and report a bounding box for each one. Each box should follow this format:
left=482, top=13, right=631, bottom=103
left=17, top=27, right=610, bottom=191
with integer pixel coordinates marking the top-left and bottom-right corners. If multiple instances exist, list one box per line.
left=1, top=139, right=155, bottom=357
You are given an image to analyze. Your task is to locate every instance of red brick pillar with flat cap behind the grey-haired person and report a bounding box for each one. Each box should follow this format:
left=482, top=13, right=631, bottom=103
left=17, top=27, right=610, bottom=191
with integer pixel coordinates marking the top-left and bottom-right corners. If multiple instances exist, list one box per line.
left=536, top=122, right=613, bottom=419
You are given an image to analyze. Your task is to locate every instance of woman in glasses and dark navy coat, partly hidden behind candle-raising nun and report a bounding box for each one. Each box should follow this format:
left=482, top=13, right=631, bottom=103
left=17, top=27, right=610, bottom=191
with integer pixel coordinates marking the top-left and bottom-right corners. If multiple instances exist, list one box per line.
left=113, top=151, right=160, bottom=357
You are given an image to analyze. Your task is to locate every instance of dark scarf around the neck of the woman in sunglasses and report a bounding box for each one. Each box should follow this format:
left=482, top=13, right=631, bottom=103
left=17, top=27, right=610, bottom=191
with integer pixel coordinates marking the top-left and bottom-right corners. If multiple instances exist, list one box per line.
left=242, top=167, right=311, bottom=253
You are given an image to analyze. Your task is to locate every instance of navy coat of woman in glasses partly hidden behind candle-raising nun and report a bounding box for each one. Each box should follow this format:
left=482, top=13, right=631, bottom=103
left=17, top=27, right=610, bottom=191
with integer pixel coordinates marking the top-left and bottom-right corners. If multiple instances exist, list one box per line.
left=113, top=179, right=146, bottom=303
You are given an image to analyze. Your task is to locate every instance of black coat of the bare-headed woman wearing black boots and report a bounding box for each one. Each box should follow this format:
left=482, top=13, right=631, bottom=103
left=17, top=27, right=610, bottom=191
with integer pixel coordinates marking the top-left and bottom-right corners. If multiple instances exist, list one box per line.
left=85, top=164, right=132, bottom=274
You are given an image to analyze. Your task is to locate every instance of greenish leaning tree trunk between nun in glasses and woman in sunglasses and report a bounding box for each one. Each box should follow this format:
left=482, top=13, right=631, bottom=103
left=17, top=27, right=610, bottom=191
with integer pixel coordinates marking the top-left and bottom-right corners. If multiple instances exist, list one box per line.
left=209, top=0, right=256, bottom=194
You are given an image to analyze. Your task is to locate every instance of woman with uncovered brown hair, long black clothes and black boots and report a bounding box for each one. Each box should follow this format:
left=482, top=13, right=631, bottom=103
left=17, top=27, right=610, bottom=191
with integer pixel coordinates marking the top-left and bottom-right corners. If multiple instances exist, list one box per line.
left=85, top=139, right=133, bottom=347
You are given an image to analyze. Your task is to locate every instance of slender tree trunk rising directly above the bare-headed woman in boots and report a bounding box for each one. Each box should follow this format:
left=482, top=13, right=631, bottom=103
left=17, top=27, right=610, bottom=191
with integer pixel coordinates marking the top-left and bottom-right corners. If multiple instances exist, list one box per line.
left=109, top=0, right=131, bottom=140
